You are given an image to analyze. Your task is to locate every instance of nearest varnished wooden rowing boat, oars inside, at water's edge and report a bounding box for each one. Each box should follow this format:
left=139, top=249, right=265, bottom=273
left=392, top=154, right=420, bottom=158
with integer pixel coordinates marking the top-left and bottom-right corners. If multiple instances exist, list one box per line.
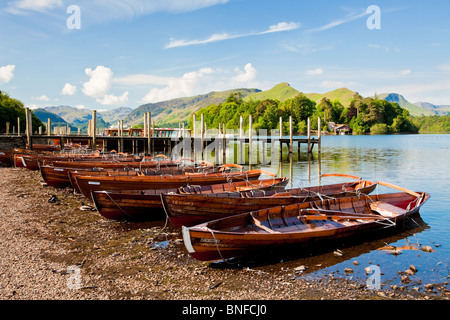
left=182, top=182, right=430, bottom=261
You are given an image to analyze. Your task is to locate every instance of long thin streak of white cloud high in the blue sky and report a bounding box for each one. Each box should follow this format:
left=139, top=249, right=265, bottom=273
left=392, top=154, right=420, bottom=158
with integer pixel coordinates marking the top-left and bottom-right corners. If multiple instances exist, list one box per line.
left=165, top=22, right=300, bottom=49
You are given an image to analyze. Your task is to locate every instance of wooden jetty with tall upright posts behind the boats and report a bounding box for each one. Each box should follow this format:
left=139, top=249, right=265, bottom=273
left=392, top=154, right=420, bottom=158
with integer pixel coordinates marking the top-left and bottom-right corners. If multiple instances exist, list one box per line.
left=1, top=109, right=321, bottom=163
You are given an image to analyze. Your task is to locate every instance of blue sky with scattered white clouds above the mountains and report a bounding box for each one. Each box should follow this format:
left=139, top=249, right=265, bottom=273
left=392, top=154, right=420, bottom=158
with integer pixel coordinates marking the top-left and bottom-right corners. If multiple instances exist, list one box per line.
left=0, top=0, right=450, bottom=110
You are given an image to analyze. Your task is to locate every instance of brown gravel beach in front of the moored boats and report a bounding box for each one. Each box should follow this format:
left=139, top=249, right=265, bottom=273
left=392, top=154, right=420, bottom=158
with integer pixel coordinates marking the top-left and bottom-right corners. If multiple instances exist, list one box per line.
left=0, top=167, right=448, bottom=300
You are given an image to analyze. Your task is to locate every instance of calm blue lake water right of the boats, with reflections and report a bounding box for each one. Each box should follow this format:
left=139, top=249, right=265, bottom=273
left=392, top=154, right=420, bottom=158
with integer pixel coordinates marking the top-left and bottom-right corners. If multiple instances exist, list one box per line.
left=227, top=135, right=450, bottom=290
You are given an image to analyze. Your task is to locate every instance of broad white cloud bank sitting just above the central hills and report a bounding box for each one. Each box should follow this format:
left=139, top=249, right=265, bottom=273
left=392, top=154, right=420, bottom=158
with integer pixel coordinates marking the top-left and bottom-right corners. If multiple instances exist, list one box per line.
left=141, top=63, right=257, bottom=103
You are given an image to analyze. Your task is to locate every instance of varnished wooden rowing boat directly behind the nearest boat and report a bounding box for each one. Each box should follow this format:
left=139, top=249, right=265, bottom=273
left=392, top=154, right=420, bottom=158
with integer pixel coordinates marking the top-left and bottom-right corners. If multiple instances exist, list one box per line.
left=161, top=174, right=377, bottom=227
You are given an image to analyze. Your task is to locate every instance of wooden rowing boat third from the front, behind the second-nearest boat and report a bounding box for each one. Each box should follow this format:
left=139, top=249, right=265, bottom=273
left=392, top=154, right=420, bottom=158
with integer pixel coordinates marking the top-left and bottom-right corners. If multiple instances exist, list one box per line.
left=91, top=178, right=289, bottom=220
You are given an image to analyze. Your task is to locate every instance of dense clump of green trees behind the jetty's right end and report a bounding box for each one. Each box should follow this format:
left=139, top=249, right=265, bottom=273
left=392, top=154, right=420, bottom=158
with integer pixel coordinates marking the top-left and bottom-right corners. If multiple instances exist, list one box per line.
left=189, top=93, right=419, bottom=134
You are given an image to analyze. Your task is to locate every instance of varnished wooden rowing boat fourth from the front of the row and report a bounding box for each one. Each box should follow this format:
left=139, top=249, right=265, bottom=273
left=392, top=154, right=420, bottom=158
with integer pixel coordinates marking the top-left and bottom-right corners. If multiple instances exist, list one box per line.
left=74, top=170, right=263, bottom=199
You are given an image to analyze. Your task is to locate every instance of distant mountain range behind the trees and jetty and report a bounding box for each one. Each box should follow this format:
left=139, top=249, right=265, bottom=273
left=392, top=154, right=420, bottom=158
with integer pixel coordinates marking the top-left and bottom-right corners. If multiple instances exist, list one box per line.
left=34, top=82, right=450, bottom=130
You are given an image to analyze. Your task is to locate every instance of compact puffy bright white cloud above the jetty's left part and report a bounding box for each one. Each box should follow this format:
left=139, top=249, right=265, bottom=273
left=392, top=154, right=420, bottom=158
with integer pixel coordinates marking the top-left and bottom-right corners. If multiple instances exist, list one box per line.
left=82, top=66, right=114, bottom=98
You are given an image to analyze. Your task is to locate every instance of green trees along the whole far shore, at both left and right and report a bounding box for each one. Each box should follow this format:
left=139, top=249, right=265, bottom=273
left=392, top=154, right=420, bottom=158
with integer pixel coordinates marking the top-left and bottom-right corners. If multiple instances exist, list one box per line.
left=0, top=91, right=450, bottom=134
